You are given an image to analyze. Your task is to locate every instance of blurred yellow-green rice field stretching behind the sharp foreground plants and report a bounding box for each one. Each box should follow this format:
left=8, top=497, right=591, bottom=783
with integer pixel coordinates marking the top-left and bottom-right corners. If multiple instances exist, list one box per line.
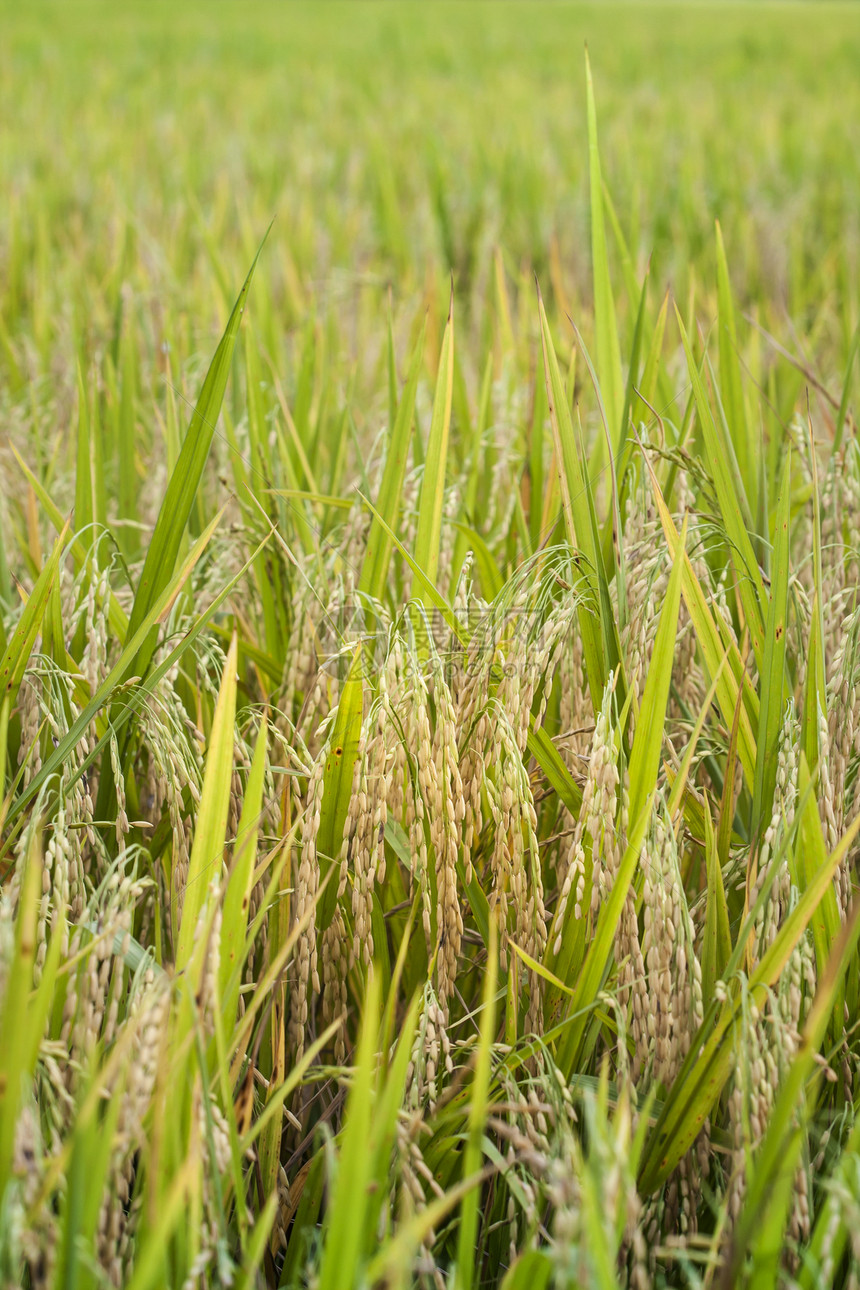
left=0, top=0, right=860, bottom=366
